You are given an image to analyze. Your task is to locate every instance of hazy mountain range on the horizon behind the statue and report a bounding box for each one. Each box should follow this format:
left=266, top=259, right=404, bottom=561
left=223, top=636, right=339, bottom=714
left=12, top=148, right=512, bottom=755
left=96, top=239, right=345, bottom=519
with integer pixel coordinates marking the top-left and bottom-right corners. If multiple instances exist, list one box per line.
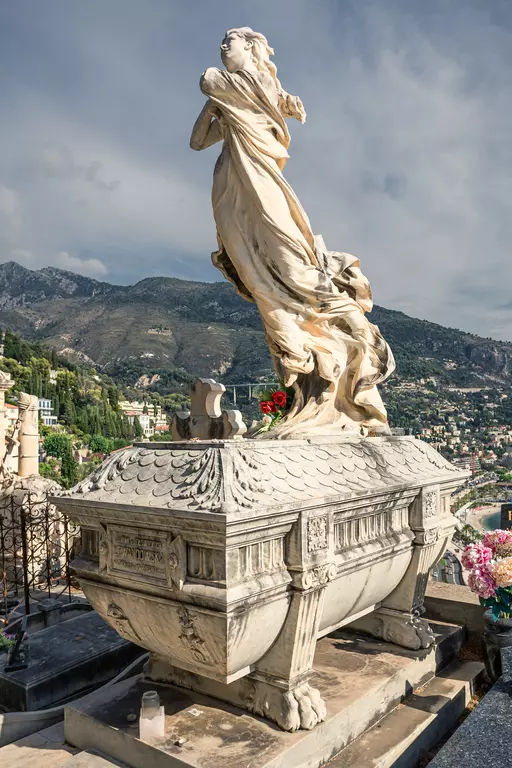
left=0, top=262, right=512, bottom=391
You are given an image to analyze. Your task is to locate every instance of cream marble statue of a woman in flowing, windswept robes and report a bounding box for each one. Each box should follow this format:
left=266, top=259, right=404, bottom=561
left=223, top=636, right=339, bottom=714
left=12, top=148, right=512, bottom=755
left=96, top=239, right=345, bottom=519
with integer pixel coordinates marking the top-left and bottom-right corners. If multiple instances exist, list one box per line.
left=190, top=27, right=395, bottom=438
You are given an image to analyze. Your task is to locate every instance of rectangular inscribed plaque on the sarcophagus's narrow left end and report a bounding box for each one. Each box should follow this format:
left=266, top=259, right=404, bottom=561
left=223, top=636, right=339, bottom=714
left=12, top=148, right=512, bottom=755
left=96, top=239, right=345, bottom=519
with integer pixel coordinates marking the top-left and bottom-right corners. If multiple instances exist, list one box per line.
left=108, top=525, right=169, bottom=586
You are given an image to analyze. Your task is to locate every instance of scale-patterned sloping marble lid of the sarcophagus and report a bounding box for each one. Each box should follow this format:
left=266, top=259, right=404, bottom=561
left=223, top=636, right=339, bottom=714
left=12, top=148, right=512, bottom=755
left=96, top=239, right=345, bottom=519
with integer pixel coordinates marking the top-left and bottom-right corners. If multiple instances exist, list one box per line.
left=74, top=437, right=460, bottom=512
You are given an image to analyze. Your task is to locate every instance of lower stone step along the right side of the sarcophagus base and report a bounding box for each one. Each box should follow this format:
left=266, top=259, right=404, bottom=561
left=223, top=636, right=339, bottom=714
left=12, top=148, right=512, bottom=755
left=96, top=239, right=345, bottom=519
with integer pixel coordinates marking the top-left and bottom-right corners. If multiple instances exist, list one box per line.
left=326, top=661, right=484, bottom=768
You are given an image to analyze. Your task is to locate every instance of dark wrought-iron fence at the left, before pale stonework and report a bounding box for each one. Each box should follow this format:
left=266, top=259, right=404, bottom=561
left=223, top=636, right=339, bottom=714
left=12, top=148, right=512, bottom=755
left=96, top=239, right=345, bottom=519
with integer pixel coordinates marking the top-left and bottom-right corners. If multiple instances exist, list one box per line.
left=0, top=493, right=80, bottom=623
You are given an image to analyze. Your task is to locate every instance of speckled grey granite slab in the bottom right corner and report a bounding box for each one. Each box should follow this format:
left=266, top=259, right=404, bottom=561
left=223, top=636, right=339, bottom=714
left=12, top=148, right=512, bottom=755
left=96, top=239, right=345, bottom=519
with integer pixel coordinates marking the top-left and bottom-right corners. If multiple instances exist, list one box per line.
left=428, top=680, right=512, bottom=768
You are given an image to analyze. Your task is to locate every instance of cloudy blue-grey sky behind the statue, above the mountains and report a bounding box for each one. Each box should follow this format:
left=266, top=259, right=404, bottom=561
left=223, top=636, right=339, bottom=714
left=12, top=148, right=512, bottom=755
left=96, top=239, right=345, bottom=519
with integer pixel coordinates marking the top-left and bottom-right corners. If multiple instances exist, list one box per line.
left=0, top=0, right=512, bottom=340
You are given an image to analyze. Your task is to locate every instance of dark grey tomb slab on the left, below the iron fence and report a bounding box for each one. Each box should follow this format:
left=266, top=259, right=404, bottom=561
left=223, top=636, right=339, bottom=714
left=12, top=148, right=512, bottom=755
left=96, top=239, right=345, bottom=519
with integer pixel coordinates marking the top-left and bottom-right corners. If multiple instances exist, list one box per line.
left=0, top=611, right=143, bottom=712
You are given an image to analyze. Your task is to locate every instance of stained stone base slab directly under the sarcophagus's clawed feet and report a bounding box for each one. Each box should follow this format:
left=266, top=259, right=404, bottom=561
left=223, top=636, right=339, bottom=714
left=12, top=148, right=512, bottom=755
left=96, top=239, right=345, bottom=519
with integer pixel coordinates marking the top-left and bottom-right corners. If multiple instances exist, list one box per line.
left=64, top=625, right=461, bottom=768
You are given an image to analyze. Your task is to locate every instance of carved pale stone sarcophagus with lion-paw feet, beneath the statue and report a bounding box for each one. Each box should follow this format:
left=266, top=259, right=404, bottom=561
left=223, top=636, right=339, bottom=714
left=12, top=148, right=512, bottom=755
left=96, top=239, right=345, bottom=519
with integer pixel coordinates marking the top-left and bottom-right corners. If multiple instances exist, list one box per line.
left=55, top=437, right=465, bottom=730
